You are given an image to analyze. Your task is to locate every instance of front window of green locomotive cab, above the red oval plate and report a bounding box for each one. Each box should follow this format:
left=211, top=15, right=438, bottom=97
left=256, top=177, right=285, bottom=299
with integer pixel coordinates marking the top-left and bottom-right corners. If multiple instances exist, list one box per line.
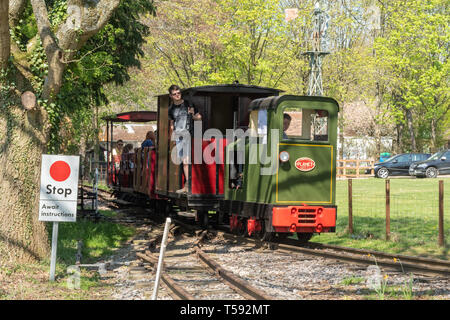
left=282, top=107, right=329, bottom=141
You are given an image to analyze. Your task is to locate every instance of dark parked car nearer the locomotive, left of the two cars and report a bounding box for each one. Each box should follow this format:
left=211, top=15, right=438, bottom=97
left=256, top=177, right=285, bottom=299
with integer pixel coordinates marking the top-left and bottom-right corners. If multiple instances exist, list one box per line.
left=374, top=153, right=430, bottom=179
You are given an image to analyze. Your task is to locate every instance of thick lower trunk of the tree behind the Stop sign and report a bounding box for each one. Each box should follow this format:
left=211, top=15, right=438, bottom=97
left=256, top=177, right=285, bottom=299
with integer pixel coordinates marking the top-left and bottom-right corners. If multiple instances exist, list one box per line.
left=0, top=97, right=49, bottom=265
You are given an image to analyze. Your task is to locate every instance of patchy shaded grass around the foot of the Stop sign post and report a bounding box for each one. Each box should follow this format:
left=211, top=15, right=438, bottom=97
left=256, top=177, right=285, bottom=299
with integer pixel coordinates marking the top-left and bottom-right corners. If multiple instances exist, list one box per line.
left=0, top=210, right=136, bottom=300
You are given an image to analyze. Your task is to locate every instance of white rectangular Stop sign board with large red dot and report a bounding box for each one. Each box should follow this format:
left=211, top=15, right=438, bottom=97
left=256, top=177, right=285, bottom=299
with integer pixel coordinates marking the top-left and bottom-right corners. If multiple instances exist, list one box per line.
left=39, top=154, right=80, bottom=222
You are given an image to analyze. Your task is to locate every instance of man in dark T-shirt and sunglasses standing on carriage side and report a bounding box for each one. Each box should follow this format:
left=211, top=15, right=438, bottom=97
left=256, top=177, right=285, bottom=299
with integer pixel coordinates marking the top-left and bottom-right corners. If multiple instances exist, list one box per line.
left=169, top=85, right=202, bottom=193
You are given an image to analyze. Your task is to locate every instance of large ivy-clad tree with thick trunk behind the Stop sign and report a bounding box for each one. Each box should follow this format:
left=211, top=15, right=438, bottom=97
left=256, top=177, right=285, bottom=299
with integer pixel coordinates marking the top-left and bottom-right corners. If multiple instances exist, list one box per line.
left=0, top=0, right=154, bottom=264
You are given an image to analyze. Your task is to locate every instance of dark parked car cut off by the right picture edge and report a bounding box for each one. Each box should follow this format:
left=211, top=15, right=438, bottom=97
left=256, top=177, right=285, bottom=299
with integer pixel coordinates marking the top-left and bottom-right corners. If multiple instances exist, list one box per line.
left=409, top=149, right=450, bottom=178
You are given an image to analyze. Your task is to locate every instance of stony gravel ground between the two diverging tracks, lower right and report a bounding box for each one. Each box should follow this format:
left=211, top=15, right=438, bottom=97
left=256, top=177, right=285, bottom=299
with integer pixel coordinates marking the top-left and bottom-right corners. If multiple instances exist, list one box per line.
left=203, top=237, right=450, bottom=300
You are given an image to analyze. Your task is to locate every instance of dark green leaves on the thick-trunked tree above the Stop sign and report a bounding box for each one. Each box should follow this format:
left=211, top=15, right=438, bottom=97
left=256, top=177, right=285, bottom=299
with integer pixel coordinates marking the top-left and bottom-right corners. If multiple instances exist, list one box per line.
left=13, top=0, right=154, bottom=154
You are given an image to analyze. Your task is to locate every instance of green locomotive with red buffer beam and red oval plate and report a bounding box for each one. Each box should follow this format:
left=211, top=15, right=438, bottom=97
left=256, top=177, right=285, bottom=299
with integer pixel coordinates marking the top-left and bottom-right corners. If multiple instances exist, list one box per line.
left=225, top=95, right=339, bottom=240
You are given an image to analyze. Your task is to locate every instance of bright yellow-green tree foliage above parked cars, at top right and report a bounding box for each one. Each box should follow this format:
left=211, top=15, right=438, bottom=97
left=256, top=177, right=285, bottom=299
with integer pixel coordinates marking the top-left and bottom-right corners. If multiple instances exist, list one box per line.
left=374, top=0, right=450, bottom=149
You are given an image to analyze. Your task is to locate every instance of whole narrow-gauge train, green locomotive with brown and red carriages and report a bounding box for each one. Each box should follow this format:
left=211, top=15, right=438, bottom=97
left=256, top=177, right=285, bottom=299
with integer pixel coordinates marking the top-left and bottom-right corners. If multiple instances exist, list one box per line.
left=105, top=84, right=339, bottom=241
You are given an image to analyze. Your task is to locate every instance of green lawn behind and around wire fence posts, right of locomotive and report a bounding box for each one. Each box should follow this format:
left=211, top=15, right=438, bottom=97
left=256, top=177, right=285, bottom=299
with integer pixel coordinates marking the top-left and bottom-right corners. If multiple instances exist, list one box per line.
left=312, top=178, right=450, bottom=259
